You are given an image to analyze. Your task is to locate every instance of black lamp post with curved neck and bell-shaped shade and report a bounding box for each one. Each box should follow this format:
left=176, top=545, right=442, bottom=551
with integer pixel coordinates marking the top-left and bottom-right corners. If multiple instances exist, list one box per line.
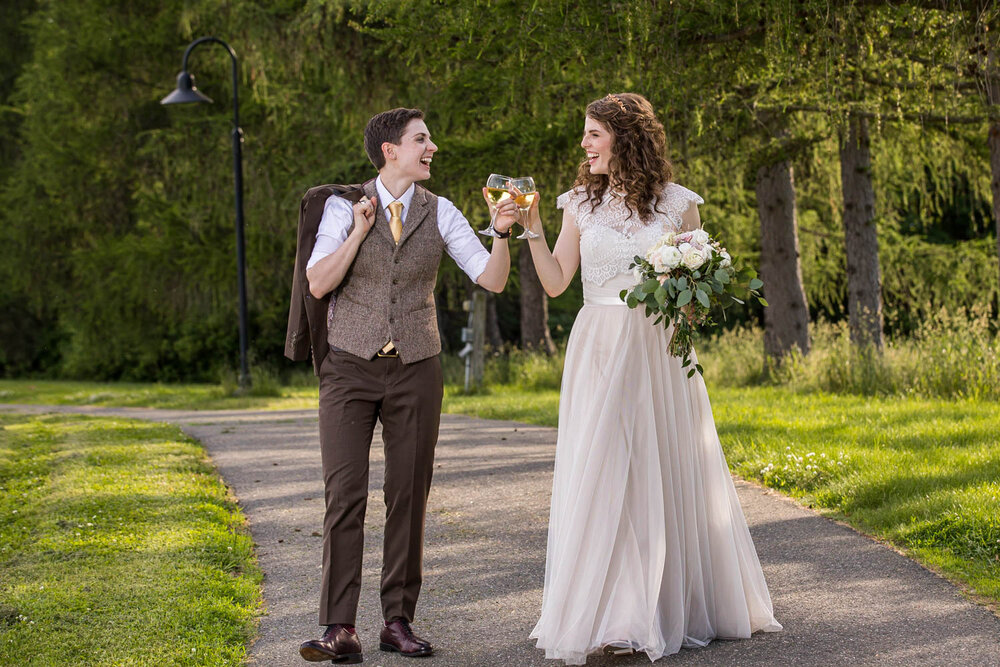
left=160, top=37, right=250, bottom=389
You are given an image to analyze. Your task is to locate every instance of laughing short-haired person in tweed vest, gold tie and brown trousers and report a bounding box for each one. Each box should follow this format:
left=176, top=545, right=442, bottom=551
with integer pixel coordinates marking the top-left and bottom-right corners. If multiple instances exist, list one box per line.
left=299, top=109, right=518, bottom=663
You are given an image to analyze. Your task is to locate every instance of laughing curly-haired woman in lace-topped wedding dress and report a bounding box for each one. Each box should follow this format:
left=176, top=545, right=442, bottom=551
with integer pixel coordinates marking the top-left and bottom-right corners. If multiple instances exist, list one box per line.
left=526, top=93, right=781, bottom=665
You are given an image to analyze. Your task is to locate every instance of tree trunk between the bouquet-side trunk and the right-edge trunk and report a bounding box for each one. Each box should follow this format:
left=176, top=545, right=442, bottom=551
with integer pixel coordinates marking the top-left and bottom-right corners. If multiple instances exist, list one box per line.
left=840, top=116, right=882, bottom=350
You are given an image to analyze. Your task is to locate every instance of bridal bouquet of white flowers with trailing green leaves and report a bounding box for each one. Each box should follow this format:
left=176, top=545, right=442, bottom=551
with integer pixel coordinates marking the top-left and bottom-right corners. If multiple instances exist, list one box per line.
left=621, top=229, right=767, bottom=377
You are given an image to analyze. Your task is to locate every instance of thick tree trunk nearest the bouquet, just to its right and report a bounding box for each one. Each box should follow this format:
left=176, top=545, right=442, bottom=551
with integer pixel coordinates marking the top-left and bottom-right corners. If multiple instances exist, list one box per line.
left=757, top=161, right=809, bottom=362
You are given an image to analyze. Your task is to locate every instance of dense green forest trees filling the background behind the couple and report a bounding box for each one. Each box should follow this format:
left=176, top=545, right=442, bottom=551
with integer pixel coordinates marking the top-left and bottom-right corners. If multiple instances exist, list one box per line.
left=0, top=0, right=1000, bottom=381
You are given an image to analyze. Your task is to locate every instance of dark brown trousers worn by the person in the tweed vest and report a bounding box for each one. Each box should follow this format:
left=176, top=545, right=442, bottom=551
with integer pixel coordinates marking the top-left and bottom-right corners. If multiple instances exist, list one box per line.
left=319, top=349, right=443, bottom=625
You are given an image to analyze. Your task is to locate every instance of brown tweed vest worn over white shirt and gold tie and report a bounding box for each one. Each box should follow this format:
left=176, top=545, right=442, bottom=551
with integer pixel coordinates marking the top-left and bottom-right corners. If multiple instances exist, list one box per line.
left=327, top=181, right=444, bottom=364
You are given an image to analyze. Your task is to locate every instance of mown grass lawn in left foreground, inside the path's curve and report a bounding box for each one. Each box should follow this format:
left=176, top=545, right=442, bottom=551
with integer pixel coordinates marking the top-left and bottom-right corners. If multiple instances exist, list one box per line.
left=0, top=414, right=261, bottom=665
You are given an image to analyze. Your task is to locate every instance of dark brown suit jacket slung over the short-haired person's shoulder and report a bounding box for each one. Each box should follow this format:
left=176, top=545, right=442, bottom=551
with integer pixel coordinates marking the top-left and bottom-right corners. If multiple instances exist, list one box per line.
left=285, top=184, right=374, bottom=375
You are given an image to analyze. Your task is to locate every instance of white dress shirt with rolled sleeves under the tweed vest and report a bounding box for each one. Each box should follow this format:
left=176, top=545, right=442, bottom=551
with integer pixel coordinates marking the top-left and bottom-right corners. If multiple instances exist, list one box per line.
left=306, top=176, right=490, bottom=282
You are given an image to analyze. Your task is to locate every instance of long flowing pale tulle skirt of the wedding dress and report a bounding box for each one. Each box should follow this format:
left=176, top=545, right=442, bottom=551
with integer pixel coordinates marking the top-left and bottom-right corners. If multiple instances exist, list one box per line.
left=531, top=280, right=781, bottom=664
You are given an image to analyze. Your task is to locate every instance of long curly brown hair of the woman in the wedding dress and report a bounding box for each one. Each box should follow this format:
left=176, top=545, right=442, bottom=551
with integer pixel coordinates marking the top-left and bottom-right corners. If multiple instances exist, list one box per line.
left=574, top=93, right=673, bottom=222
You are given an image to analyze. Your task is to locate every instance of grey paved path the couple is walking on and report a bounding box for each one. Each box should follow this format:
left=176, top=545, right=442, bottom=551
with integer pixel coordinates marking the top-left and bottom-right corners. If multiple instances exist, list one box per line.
left=0, top=405, right=1000, bottom=667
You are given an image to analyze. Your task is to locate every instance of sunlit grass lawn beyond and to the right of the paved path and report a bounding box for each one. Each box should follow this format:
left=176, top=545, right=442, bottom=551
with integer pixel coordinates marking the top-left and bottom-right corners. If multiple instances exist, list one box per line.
left=0, top=381, right=1000, bottom=620
